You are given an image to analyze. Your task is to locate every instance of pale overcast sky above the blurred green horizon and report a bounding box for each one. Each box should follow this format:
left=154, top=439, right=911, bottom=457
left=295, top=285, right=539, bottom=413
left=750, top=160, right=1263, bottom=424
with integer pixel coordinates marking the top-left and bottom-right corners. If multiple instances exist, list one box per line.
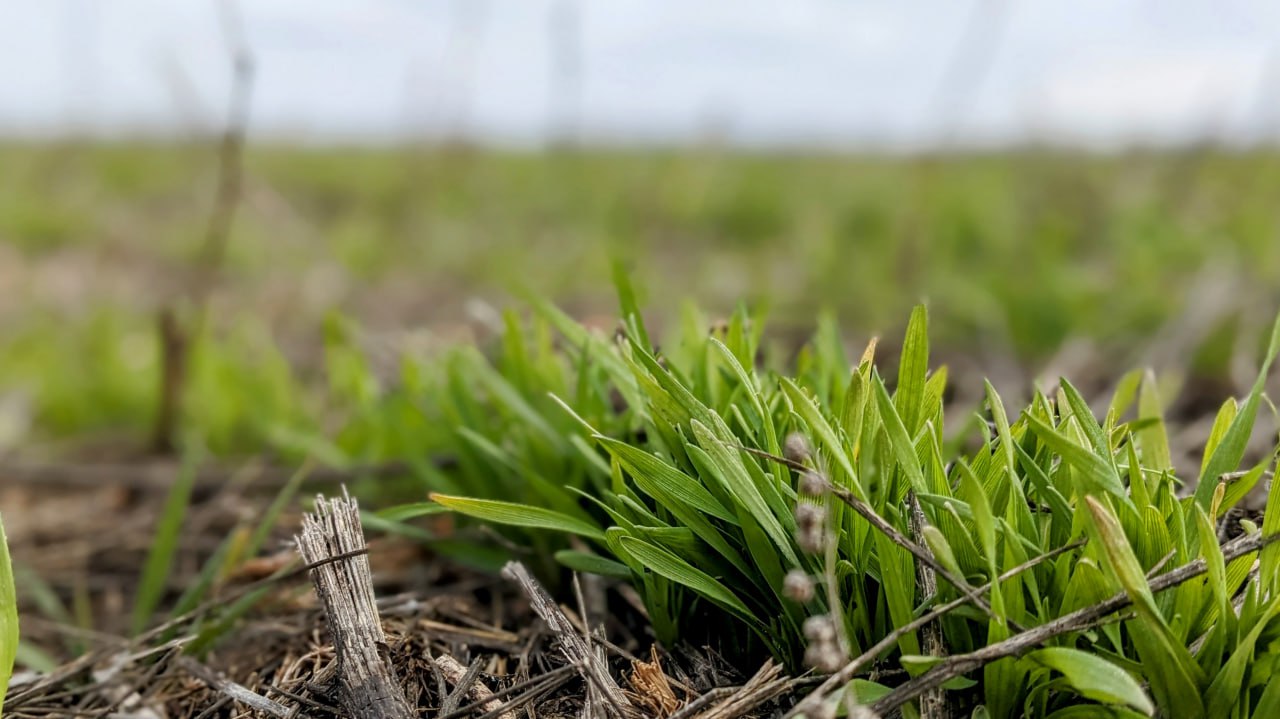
left=0, top=0, right=1280, bottom=147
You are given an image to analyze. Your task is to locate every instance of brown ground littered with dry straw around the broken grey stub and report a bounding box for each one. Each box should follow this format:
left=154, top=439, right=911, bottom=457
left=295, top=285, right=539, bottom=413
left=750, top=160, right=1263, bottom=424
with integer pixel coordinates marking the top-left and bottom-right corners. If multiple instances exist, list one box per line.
left=0, top=465, right=798, bottom=719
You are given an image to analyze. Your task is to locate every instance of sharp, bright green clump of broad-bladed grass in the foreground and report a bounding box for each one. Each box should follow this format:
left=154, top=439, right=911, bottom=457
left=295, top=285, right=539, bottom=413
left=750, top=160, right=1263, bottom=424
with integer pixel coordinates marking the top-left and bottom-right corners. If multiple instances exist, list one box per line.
left=404, top=296, right=1280, bottom=716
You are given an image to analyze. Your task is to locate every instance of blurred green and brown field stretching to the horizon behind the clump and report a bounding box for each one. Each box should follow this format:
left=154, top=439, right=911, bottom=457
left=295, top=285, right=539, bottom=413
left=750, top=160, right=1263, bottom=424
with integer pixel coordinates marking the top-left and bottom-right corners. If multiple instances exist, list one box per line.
left=0, top=143, right=1280, bottom=447
